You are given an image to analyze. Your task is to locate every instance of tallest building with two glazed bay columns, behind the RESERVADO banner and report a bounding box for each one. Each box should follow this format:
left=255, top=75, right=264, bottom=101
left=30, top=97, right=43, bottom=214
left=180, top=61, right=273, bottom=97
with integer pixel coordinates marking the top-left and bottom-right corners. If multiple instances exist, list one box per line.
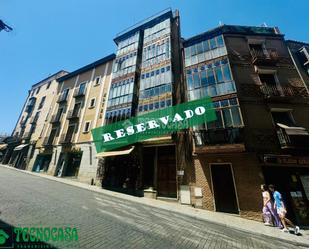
left=100, top=10, right=184, bottom=199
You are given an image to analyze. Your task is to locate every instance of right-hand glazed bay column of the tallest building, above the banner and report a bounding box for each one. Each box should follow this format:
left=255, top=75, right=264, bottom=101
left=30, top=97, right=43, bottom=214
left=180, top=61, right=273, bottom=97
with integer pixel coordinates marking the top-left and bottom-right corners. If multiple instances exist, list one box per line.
left=138, top=18, right=173, bottom=114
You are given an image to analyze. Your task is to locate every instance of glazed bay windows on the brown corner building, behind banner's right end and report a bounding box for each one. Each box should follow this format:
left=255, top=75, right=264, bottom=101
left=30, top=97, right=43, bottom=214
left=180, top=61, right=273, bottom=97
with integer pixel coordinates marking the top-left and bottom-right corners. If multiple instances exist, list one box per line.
left=185, top=35, right=243, bottom=131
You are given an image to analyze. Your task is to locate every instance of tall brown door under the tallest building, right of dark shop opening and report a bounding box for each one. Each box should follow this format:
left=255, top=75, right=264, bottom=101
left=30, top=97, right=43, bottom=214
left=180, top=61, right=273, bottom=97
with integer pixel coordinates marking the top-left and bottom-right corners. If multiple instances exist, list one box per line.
left=157, top=146, right=177, bottom=198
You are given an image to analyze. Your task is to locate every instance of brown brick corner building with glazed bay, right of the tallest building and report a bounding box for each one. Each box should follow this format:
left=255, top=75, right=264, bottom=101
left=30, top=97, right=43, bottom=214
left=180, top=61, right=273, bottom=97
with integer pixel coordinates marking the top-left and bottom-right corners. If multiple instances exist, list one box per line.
left=184, top=25, right=309, bottom=225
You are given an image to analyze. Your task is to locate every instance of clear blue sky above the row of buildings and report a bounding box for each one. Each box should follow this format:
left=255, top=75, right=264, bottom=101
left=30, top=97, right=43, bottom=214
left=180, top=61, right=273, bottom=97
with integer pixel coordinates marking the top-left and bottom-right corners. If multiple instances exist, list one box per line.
left=0, top=0, right=309, bottom=133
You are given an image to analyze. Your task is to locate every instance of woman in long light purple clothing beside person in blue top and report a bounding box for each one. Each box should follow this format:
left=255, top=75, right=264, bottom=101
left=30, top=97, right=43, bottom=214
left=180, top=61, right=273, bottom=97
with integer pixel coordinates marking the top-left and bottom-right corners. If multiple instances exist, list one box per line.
left=261, top=184, right=282, bottom=228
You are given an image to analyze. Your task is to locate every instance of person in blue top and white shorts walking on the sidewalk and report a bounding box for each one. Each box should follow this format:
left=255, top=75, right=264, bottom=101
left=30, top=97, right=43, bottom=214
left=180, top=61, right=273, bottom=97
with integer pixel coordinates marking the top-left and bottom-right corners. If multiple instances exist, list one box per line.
left=268, top=184, right=300, bottom=235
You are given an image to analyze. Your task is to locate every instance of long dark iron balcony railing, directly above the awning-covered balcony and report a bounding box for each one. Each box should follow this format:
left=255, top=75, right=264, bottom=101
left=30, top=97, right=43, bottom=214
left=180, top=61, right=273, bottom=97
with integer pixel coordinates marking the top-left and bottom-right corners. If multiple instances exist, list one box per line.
left=260, top=83, right=308, bottom=98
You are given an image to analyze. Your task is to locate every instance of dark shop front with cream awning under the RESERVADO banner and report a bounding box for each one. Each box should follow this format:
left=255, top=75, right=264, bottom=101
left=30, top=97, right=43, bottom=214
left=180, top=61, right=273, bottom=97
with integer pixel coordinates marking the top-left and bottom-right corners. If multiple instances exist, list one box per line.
left=97, top=144, right=177, bottom=199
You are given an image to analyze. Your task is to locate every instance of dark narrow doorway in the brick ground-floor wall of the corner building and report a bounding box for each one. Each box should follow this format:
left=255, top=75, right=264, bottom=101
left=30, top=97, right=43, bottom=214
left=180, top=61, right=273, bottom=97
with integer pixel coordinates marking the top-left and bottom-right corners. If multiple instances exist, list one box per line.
left=211, top=164, right=238, bottom=214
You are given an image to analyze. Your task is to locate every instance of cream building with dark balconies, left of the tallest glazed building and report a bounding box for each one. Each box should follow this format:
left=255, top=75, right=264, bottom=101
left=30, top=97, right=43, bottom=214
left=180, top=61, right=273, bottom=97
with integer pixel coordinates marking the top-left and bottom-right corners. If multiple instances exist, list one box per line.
left=38, top=54, right=115, bottom=184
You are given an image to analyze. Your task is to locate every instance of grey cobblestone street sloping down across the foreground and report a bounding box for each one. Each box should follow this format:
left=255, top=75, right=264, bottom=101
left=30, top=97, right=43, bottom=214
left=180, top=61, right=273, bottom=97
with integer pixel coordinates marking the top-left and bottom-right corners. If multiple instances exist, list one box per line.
left=0, top=167, right=305, bottom=249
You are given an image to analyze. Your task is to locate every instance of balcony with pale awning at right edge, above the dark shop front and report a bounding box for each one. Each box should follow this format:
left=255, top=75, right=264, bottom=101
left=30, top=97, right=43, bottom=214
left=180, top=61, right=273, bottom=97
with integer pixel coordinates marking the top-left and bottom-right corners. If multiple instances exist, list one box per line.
left=276, top=124, right=309, bottom=150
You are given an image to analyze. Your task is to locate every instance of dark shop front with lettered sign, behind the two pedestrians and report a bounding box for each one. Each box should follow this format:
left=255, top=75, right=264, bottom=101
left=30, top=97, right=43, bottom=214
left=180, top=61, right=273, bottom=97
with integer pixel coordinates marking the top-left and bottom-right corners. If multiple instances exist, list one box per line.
left=263, top=155, right=309, bottom=226
